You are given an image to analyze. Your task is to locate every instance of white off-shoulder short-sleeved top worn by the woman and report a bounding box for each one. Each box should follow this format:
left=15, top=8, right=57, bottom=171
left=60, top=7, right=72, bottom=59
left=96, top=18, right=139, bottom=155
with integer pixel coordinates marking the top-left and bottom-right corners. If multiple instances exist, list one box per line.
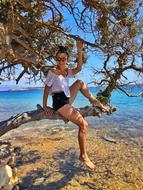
left=45, top=69, right=72, bottom=97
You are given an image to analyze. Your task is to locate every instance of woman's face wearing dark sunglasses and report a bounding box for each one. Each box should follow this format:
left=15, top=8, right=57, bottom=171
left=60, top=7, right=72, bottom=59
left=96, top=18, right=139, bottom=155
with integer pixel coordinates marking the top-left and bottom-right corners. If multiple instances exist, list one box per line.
left=56, top=53, right=68, bottom=69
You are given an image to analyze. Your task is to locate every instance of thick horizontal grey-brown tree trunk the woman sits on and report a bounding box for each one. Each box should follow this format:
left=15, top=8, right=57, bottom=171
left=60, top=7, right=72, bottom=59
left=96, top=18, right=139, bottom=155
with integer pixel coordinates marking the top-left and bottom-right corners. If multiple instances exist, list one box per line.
left=0, top=104, right=111, bottom=136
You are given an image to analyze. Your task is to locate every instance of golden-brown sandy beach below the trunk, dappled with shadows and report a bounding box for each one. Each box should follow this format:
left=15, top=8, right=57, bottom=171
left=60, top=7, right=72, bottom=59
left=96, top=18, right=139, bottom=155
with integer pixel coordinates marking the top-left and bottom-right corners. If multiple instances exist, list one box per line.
left=1, top=121, right=143, bottom=190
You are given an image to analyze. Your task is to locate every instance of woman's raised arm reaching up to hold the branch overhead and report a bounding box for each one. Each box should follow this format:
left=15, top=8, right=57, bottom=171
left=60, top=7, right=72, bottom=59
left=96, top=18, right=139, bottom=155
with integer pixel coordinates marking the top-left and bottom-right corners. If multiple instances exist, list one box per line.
left=72, top=41, right=83, bottom=75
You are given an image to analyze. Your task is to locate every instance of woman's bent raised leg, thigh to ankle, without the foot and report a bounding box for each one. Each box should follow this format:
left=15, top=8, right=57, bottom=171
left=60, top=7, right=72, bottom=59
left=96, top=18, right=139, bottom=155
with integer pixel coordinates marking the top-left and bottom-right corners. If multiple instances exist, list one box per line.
left=70, top=80, right=97, bottom=104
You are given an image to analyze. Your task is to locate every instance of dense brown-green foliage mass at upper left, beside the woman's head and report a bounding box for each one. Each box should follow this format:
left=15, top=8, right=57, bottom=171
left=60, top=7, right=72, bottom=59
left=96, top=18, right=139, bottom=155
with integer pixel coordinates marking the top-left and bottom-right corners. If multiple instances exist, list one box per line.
left=0, top=0, right=73, bottom=83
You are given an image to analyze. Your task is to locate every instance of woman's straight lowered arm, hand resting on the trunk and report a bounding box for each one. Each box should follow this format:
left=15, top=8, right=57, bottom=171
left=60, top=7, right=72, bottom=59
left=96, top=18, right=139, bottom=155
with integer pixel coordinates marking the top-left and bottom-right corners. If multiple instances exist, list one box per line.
left=43, top=85, right=54, bottom=116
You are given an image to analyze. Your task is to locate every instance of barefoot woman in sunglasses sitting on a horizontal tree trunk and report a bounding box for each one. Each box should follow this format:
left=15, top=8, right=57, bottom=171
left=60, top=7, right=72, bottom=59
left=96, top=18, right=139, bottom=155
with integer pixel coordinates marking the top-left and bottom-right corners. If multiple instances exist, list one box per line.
left=43, top=41, right=107, bottom=169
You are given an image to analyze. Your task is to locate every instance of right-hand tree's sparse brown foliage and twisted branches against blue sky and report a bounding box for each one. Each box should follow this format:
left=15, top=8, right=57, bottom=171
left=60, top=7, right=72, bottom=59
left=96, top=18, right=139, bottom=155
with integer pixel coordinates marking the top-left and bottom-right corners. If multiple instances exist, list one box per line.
left=69, top=0, right=143, bottom=103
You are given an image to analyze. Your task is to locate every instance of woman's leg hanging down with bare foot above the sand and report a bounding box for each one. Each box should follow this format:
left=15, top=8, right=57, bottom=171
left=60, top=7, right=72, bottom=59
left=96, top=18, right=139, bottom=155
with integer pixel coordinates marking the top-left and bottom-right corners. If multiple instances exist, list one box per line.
left=58, top=104, right=95, bottom=169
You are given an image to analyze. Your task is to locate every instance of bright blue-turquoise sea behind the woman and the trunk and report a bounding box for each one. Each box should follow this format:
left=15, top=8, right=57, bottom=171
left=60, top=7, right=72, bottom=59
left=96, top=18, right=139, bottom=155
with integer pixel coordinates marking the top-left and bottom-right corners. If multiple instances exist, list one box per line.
left=0, top=86, right=143, bottom=137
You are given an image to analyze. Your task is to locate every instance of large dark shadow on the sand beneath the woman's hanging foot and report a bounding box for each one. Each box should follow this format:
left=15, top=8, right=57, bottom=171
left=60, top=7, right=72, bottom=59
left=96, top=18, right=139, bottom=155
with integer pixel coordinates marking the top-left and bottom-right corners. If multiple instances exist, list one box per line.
left=20, top=149, right=88, bottom=190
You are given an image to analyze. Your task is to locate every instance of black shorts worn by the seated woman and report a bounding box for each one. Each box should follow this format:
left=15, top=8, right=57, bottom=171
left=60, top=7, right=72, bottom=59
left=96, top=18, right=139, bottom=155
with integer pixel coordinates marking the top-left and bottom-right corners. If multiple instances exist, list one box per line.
left=52, top=92, right=69, bottom=111
